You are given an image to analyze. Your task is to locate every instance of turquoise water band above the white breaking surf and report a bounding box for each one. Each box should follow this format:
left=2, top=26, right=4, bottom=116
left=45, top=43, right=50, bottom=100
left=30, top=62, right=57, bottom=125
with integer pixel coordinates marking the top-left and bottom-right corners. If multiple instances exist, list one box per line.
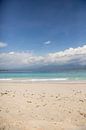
left=0, top=70, right=86, bottom=80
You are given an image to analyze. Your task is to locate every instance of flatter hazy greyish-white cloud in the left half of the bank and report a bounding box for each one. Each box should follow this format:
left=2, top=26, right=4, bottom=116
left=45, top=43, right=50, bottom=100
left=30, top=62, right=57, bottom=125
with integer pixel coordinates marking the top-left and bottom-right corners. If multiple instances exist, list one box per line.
left=0, top=52, right=43, bottom=68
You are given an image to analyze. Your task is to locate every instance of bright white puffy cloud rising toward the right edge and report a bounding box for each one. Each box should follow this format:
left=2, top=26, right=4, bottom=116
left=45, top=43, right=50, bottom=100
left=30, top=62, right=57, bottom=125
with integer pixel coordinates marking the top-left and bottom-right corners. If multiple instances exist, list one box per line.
left=47, top=45, right=86, bottom=64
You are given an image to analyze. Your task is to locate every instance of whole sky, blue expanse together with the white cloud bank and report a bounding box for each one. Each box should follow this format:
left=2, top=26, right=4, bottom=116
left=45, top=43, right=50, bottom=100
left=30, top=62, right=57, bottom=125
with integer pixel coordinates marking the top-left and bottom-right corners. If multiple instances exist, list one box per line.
left=0, top=0, right=86, bottom=69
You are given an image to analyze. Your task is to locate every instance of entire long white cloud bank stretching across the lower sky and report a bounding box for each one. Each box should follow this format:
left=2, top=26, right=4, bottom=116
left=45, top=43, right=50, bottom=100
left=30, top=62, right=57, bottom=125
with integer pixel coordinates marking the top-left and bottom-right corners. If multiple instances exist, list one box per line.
left=0, top=45, right=86, bottom=69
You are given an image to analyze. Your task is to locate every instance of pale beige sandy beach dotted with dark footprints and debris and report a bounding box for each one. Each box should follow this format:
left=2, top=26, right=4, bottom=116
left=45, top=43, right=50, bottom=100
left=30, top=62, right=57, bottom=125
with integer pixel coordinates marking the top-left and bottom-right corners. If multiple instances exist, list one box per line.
left=0, top=80, right=86, bottom=130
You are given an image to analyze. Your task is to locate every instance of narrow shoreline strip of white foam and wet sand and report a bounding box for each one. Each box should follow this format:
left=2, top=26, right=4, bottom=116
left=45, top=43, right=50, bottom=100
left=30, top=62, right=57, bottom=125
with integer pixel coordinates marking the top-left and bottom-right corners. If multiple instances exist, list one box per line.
left=0, top=78, right=86, bottom=84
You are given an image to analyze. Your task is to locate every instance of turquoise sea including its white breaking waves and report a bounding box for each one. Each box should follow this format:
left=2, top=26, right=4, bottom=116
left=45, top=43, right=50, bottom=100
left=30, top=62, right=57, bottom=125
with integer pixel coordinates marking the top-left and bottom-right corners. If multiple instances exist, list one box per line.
left=0, top=70, right=86, bottom=81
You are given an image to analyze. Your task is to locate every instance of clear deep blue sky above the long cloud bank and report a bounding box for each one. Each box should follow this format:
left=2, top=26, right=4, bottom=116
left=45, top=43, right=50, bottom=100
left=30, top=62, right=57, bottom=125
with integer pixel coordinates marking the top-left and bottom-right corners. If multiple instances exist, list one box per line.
left=0, top=0, right=86, bottom=69
